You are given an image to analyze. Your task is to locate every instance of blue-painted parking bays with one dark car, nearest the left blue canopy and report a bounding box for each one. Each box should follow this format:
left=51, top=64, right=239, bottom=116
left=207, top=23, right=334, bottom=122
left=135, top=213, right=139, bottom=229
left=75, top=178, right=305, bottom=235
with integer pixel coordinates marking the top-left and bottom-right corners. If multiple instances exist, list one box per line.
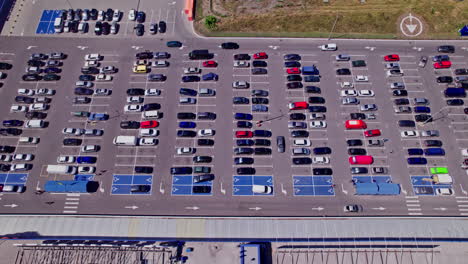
left=110, top=174, right=153, bottom=195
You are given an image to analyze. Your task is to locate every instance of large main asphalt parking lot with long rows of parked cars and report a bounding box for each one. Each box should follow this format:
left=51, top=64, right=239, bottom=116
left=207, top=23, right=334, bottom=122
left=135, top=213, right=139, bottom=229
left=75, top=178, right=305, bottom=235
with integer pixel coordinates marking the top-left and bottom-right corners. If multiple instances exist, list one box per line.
left=0, top=37, right=468, bottom=215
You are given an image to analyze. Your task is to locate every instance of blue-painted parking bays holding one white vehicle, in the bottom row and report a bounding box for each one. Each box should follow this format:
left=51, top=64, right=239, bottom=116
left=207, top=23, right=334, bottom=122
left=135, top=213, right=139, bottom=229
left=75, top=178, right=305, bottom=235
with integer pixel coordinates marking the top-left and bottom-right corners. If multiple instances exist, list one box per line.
left=232, top=175, right=275, bottom=196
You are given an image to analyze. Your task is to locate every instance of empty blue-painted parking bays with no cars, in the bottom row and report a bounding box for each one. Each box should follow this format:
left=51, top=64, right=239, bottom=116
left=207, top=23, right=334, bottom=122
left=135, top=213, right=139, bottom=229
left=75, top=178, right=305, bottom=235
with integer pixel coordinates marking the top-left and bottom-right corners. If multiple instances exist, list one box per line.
left=293, top=176, right=335, bottom=196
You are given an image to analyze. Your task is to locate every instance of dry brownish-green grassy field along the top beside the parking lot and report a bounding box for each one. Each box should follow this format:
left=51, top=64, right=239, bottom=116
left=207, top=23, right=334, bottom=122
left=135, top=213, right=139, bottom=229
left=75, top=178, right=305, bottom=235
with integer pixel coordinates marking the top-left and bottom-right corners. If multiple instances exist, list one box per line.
left=196, top=0, right=468, bottom=39
